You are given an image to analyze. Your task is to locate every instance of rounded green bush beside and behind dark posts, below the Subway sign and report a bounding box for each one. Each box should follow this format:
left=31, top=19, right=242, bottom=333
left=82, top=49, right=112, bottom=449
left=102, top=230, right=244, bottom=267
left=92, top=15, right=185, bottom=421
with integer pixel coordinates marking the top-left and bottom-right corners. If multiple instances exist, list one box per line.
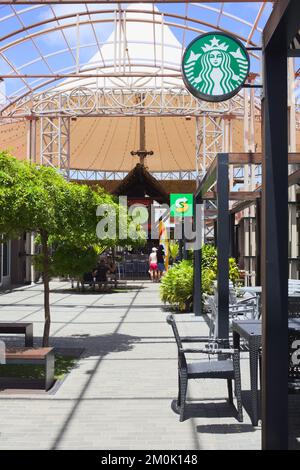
left=160, top=245, right=239, bottom=310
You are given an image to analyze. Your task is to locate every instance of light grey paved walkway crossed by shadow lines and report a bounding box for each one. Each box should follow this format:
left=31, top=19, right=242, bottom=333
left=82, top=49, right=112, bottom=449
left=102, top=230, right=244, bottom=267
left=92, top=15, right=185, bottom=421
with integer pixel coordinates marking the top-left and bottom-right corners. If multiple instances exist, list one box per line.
left=0, top=282, right=296, bottom=450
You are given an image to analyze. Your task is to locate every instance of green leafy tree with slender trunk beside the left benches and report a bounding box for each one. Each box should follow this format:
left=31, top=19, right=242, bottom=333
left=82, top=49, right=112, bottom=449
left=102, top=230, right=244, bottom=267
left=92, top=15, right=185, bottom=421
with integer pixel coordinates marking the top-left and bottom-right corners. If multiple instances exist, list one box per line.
left=0, top=152, right=125, bottom=346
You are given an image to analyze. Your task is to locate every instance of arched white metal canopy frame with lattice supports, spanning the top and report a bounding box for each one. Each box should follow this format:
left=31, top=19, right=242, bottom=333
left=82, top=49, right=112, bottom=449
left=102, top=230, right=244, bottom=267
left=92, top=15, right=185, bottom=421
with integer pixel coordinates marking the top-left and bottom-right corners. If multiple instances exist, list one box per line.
left=0, top=1, right=272, bottom=177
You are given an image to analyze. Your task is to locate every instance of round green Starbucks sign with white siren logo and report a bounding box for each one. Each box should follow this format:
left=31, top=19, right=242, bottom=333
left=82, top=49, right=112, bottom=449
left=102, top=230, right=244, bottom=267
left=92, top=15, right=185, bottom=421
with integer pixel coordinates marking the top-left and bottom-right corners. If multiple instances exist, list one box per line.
left=182, top=31, right=249, bottom=101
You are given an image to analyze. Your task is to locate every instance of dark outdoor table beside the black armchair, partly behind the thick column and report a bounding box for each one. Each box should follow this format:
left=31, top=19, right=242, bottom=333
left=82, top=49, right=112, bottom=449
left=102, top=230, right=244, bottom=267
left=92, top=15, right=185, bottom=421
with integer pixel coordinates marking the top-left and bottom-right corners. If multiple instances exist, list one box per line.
left=232, top=318, right=300, bottom=426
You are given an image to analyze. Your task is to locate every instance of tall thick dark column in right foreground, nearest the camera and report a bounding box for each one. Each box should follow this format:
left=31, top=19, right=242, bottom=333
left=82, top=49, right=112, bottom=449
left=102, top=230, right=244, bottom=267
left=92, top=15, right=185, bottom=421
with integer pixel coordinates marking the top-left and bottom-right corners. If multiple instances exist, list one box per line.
left=262, top=30, right=288, bottom=449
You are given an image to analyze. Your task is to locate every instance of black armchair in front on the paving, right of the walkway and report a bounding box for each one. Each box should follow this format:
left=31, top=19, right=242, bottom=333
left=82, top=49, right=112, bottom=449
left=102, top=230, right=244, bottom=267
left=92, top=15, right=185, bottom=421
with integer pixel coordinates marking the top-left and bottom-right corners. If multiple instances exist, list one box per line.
left=167, top=315, right=243, bottom=422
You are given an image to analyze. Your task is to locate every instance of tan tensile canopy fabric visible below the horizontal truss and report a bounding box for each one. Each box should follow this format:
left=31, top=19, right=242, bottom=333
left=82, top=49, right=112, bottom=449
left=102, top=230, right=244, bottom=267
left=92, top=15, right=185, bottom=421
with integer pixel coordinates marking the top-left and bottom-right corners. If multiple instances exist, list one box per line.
left=0, top=117, right=261, bottom=171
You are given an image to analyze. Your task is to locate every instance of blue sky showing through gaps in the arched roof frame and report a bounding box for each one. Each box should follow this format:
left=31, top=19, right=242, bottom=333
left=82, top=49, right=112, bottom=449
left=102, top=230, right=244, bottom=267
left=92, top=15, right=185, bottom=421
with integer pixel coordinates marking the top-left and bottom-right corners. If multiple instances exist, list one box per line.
left=0, top=2, right=272, bottom=102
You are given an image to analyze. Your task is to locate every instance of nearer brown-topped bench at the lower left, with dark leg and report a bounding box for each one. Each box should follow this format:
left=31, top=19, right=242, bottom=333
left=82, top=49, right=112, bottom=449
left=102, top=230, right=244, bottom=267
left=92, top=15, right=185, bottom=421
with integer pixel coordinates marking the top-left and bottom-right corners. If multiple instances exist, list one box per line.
left=4, top=348, right=54, bottom=391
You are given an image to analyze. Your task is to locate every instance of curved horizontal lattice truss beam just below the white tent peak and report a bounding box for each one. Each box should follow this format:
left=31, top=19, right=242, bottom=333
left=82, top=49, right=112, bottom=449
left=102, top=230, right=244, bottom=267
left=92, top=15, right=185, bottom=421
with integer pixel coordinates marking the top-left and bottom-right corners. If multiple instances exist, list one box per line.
left=1, top=86, right=243, bottom=118
